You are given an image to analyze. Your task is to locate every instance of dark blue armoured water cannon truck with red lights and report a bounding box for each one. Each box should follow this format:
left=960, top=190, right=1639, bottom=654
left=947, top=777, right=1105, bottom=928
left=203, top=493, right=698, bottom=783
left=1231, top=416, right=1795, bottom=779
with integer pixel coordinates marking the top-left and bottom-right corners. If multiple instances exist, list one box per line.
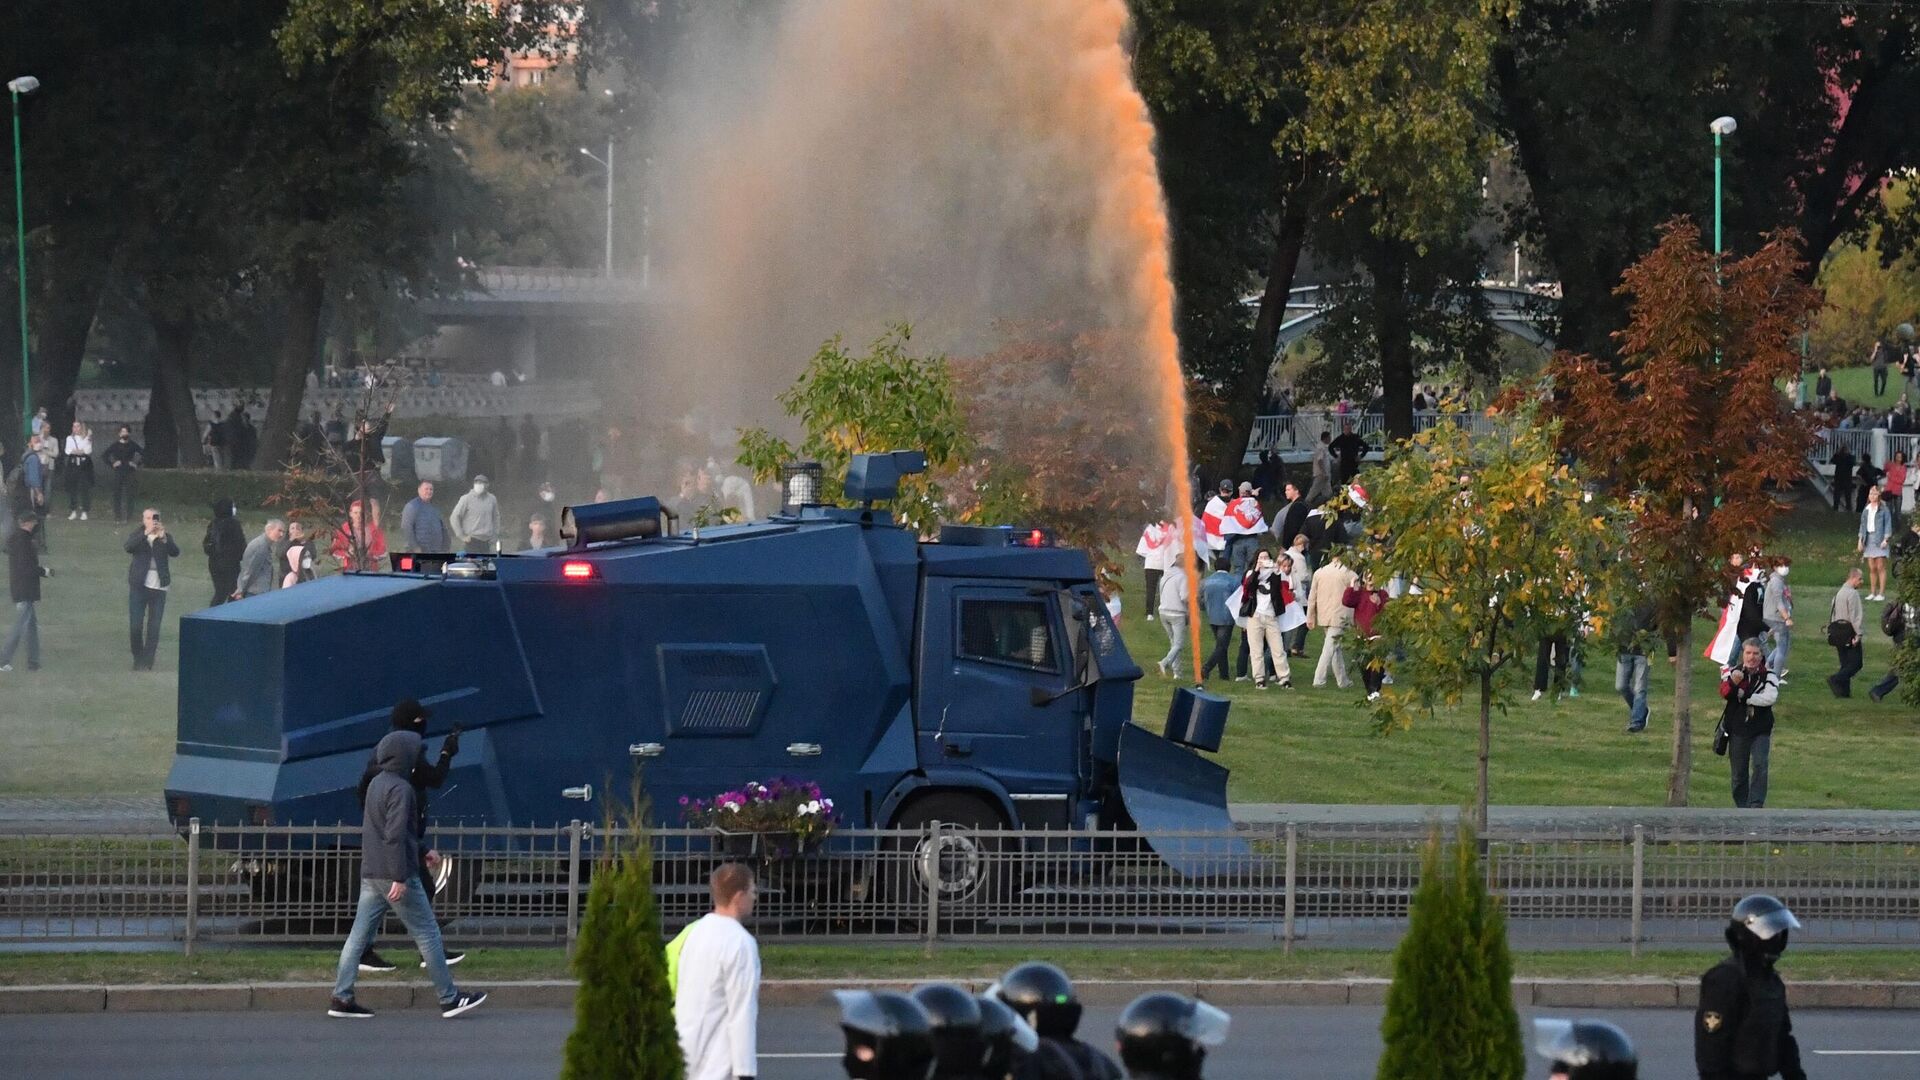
left=165, top=452, right=1233, bottom=887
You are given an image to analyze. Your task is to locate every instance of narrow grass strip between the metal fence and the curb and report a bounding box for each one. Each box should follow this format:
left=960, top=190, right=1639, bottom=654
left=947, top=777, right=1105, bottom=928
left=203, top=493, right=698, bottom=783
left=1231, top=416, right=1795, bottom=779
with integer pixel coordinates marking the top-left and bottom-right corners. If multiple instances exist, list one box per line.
left=0, top=942, right=1920, bottom=986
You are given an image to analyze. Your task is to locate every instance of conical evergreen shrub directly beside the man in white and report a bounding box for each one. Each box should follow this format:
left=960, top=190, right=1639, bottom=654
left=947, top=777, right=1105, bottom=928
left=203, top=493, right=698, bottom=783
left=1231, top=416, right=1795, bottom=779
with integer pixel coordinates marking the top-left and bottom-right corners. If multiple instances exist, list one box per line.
left=561, top=782, right=685, bottom=1080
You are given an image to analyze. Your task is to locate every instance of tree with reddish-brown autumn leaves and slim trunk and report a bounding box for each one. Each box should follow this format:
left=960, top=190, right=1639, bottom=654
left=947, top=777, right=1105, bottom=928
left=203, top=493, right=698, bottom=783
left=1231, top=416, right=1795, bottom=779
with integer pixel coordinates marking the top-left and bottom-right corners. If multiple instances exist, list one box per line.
left=1546, top=219, right=1820, bottom=805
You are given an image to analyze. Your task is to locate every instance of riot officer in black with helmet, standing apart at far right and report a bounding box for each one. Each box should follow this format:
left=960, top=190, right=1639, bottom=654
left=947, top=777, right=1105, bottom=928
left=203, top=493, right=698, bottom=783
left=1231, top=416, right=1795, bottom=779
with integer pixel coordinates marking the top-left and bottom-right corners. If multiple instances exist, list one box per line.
left=1693, top=894, right=1807, bottom=1080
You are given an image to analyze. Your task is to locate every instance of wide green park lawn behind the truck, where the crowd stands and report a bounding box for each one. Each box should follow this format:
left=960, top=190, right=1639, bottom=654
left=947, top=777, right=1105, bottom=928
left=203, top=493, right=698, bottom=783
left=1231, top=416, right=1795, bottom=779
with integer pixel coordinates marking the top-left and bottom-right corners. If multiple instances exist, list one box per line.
left=0, top=491, right=1920, bottom=809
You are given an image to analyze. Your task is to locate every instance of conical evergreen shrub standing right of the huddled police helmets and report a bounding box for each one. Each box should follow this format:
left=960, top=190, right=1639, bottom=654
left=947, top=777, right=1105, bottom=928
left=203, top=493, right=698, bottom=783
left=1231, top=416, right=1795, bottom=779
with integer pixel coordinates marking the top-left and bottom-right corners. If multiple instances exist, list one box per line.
left=1375, top=826, right=1526, bottom=1080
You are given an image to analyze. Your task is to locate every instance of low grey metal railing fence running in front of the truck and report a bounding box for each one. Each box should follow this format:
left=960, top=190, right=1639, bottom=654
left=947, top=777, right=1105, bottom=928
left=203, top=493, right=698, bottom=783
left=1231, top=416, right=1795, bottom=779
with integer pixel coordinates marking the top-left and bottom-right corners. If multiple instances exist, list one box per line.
left=0, top=822, right=1920, bottom=953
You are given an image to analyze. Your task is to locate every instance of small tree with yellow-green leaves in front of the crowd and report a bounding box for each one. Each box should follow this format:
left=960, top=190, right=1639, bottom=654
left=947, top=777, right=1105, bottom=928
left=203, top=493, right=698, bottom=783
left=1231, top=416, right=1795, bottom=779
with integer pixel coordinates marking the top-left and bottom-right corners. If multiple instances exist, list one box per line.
left=1354, top=405, right=1620, bottom=826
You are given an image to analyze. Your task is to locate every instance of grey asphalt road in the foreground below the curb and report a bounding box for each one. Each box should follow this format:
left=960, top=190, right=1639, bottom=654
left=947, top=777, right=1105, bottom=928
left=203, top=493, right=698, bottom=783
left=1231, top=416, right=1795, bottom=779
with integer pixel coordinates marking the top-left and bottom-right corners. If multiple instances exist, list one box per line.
left=0, top=1007, right=1920, bottom=1080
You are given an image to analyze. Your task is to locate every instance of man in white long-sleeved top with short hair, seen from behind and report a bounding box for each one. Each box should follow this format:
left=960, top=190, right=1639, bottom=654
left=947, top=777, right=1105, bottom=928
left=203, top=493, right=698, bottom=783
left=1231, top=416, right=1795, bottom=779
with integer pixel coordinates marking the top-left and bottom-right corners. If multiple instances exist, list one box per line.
left=674, top=863, right=760, bottom=1080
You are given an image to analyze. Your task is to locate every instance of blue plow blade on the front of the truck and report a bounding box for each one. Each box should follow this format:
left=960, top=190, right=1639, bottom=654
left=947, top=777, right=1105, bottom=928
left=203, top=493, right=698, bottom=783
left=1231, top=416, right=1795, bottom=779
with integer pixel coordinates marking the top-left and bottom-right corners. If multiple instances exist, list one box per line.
left=1116, top=724, right=1254, bottom=882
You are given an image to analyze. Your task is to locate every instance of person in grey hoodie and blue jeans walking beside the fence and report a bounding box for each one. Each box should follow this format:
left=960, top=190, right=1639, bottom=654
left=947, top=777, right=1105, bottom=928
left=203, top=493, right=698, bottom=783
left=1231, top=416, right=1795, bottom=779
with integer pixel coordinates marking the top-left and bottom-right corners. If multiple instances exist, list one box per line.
left=326, top=730, right=486, bottom=1020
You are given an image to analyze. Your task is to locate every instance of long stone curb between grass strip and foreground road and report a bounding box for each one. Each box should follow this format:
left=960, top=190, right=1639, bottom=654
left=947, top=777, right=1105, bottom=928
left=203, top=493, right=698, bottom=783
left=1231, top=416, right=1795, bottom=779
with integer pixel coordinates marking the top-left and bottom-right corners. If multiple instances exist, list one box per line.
left=0, top=978, right=1920, bottom=1015
